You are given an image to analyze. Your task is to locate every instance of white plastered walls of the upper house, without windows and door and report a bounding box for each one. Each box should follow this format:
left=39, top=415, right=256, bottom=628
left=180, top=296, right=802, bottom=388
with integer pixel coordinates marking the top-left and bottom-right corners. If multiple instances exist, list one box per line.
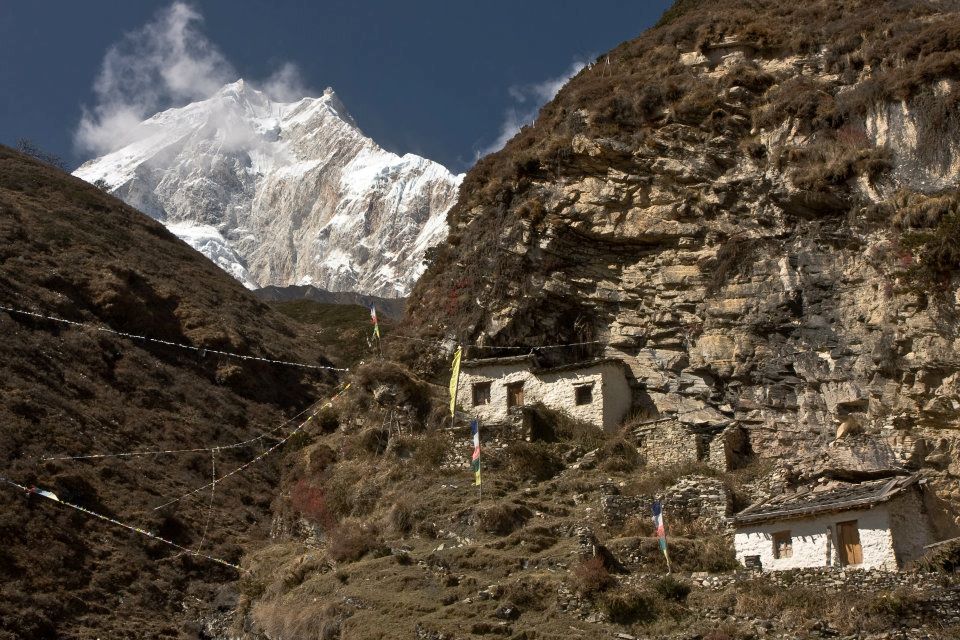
left=457, top=362, right=632, bottom=430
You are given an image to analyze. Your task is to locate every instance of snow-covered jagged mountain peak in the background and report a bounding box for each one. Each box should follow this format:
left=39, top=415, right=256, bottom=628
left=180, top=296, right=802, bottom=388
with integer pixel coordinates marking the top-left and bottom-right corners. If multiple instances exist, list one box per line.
left=74, top=80, right=462, bottom=297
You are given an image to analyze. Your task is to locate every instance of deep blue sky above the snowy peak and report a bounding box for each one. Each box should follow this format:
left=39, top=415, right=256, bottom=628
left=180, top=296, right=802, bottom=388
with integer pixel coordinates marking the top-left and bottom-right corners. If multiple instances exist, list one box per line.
left=0, top=0, right=670, bottom=171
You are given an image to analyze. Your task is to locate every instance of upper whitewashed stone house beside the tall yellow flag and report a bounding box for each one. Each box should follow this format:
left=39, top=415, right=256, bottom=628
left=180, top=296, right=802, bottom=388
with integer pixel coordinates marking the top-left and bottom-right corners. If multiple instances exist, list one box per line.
left=457, top=356, right=632, bottom=430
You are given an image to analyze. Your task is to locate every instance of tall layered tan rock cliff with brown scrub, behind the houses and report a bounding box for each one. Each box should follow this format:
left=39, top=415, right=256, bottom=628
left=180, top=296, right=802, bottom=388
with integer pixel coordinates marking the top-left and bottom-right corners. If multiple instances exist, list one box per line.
left=408, top=2, right=960, bottom=516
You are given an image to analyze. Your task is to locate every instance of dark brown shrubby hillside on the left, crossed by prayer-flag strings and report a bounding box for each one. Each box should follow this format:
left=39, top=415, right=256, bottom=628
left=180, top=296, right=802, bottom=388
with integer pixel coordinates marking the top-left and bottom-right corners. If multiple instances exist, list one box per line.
left=0, top=147, right=334, bottom=639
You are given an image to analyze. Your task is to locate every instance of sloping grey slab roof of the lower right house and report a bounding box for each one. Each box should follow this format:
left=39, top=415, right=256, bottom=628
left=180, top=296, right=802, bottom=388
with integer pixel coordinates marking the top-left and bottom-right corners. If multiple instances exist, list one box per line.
left=731, top=475, right=920, bottom=526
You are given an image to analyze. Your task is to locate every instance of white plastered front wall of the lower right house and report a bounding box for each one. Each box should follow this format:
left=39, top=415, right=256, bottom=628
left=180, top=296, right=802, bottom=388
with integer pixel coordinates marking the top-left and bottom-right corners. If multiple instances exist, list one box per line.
left=733, top=504, right=898, bottom=571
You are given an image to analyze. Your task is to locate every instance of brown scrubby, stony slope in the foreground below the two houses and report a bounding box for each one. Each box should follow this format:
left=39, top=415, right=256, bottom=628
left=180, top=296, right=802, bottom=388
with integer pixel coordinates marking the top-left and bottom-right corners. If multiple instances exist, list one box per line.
left=218, top=364, right=960, bottom=640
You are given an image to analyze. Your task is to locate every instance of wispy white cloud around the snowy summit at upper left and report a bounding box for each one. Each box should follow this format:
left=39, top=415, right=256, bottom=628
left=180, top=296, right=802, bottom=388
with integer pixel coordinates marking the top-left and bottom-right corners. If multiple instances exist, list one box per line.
left=74, top=0, right=316, bottom=155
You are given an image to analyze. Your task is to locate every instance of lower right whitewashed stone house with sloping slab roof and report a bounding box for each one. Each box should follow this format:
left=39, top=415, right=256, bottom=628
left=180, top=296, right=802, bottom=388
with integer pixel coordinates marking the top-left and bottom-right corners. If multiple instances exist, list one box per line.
left=731, top=475, right=933, bottom=571
